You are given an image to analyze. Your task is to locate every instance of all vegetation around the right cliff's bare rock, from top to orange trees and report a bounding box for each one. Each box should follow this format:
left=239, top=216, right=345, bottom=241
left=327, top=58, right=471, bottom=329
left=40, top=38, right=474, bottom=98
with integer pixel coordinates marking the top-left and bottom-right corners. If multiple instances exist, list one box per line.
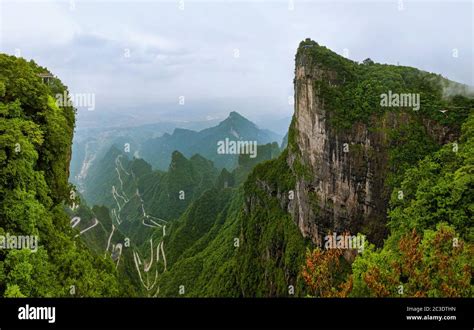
left=296, top=40, right=474, bottom=297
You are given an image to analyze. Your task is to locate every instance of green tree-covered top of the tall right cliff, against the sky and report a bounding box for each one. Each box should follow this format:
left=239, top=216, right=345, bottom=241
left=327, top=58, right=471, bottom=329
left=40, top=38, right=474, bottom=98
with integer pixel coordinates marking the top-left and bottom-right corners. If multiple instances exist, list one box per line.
left=296, top=39, right=474, bottom=133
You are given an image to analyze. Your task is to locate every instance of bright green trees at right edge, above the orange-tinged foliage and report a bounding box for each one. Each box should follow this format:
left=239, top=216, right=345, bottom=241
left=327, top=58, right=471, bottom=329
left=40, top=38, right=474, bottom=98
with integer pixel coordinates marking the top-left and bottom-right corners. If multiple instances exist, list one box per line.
left=389, top=113, right=474, bottom=242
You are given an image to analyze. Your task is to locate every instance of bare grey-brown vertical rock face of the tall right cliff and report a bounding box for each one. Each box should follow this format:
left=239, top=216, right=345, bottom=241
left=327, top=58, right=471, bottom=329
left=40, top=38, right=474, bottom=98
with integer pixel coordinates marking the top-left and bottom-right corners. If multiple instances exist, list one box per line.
left=289, top=54, right=386, bottom=244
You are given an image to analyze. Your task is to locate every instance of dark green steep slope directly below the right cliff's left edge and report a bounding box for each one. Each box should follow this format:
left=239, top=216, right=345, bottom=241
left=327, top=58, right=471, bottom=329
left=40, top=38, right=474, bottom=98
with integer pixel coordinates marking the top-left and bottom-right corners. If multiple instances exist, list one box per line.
left=237, top=186, right=309, bottom=297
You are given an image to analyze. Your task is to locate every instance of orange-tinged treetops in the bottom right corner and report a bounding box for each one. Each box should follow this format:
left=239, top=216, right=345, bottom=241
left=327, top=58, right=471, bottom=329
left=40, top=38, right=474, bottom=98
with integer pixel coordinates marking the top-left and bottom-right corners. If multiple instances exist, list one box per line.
left=351, top=223, right=474, bottom=297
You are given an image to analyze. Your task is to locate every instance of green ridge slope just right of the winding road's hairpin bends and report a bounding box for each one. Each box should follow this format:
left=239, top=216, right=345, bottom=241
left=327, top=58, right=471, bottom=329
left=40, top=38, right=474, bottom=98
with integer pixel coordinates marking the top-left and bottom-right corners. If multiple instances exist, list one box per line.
left=126, top=143, right=280, bottom=297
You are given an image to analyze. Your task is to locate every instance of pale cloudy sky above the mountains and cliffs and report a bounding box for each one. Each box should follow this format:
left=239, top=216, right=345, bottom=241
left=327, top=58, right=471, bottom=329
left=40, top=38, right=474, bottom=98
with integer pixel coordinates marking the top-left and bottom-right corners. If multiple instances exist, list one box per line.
left=0, top=0, right=474, bottom=126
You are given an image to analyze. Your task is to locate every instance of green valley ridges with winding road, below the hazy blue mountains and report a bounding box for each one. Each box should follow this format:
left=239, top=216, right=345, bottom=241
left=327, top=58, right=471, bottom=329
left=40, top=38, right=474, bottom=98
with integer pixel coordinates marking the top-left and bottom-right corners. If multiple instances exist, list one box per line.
left=75, top=135, right=280, bottom=297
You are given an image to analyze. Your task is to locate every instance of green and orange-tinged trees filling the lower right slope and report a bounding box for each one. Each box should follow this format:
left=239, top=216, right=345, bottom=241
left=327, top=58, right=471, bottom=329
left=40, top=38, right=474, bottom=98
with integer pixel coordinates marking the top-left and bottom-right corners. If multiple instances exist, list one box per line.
left=305, top=114, right=474, bottom=297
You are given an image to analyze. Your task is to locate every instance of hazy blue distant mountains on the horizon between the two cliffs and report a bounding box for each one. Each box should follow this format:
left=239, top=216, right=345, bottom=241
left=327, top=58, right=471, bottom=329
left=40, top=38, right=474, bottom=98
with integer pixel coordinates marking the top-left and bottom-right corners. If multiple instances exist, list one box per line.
left=70, top=112, right=281, bottom=192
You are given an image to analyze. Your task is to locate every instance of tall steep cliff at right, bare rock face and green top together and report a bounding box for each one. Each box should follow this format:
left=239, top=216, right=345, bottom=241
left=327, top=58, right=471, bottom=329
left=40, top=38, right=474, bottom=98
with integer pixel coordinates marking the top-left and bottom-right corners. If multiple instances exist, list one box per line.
left=287, top=40, right=468, bottom=245
